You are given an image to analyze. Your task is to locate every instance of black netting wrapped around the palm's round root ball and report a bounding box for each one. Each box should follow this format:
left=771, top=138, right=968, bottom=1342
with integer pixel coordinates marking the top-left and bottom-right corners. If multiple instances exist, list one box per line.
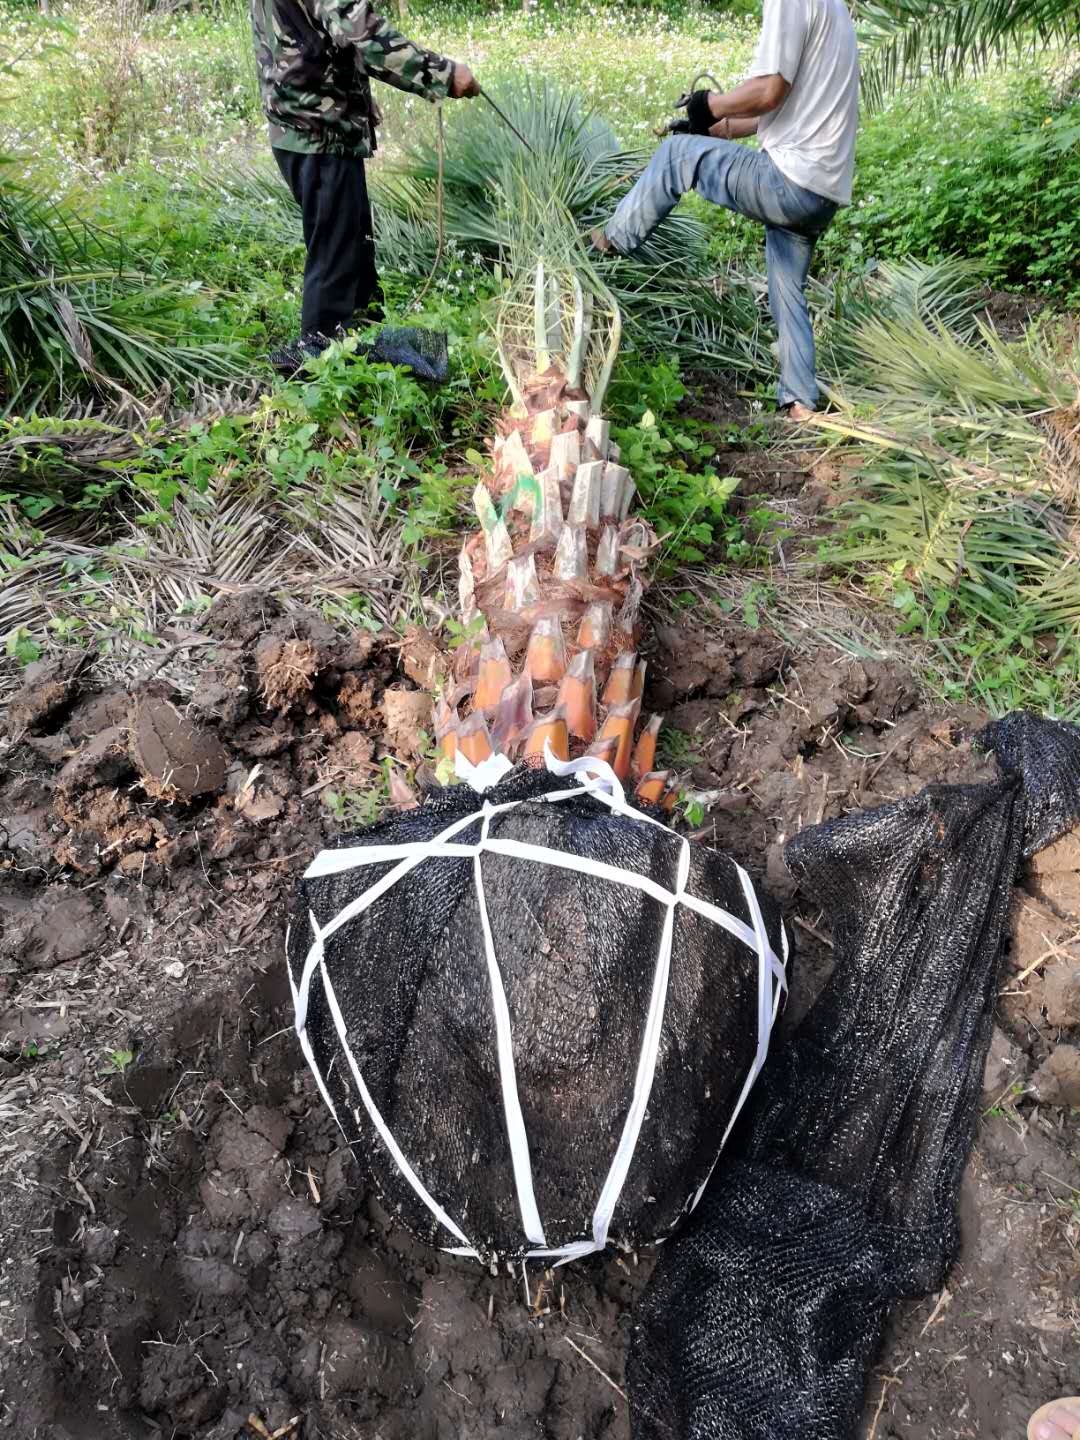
left=288, top=770, right=780, bottom=1256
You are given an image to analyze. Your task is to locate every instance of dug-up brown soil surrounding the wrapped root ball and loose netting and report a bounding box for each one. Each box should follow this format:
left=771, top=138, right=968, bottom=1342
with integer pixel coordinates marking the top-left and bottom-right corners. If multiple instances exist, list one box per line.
left=0, top=595, right=1080, bottom=1440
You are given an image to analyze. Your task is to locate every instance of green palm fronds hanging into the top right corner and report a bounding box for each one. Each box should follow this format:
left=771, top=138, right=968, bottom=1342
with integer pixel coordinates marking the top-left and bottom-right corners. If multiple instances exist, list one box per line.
left=855, top=0, right=1080, bottom=105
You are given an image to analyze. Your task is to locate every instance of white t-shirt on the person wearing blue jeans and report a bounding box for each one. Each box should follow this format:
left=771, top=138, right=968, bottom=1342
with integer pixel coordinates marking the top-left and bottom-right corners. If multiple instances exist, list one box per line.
left=750, top=0, right=858, bottom=204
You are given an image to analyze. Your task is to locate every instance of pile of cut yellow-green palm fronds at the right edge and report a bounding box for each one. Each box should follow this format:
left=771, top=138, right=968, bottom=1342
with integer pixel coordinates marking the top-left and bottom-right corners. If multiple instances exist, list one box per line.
left=818, top=264, right=1080, bottom=685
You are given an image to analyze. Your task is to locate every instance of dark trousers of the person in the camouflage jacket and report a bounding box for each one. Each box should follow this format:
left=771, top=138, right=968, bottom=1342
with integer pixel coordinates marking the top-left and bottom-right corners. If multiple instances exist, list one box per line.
left=274, top=150, right=383, bottom=336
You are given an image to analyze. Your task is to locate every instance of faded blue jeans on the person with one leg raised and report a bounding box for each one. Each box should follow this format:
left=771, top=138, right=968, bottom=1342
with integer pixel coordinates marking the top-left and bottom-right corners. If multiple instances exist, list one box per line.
left=605, top=135, right=837, bottom=409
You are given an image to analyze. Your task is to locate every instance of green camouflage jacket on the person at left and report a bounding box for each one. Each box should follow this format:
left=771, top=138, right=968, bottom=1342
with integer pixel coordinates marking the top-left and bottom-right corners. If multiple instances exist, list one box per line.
left=251, top=0, right=454, bottom=156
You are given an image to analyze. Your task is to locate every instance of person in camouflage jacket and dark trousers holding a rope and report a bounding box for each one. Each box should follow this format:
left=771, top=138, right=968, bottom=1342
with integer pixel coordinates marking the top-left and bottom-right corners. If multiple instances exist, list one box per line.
left=251, top=0, right=480, bottom=372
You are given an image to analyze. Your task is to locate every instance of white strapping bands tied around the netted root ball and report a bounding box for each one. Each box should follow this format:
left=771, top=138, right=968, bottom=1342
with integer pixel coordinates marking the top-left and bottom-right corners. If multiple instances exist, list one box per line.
left=289, top=747, right=788, bottom=1264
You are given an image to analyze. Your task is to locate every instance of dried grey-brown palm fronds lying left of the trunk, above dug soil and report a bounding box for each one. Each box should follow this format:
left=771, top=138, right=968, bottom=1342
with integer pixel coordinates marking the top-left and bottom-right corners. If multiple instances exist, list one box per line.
left=0, top=474, right=418, bottom=690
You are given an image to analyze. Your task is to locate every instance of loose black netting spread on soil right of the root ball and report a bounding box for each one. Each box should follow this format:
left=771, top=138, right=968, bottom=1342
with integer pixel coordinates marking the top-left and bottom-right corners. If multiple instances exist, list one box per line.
left=626, top=716, right=1080, bottom=1440
